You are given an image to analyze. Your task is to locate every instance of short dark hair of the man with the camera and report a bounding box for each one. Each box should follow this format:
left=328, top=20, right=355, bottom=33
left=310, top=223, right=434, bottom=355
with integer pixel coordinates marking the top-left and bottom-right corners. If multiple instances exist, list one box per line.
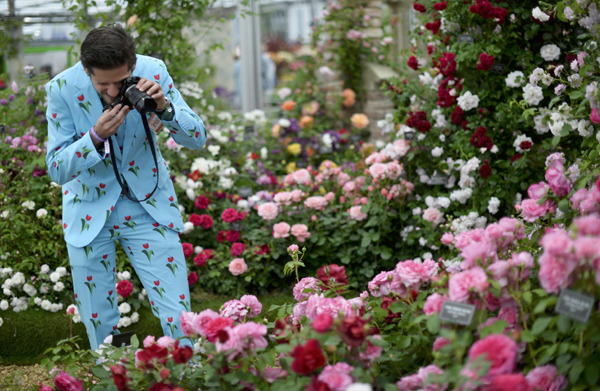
left=79, top=24, right=136, bottom=74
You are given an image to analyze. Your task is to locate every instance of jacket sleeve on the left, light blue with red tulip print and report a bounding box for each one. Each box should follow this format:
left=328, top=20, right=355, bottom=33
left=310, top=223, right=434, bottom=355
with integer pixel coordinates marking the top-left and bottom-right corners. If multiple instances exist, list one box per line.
left=46, top=81, right=102, bottom=185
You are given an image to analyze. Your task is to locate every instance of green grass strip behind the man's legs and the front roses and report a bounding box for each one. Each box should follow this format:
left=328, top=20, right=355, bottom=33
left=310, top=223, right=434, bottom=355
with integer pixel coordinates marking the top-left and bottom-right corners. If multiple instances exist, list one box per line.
left=0, top=292, right=295, bottom=366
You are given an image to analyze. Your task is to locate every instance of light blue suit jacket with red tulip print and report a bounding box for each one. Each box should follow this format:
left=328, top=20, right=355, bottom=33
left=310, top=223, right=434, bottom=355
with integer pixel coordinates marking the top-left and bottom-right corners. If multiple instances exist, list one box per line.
left=46, top=55, right=206, bottom=247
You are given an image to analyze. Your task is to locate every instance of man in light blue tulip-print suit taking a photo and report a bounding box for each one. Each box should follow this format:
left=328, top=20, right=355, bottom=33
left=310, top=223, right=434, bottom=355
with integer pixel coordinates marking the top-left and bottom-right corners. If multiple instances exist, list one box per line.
left=46, top=25, right=206, bottom=349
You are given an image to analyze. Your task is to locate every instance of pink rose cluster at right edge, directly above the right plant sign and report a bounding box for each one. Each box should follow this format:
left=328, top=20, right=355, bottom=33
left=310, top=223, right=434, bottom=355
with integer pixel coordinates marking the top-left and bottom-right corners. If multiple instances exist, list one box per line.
left=538, top=214, right=600, bottom=293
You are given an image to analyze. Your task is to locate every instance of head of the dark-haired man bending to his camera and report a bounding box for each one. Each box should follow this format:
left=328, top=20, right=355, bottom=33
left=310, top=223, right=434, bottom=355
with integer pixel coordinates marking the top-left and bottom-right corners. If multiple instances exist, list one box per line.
left=80, top=25, right=136, bottom=103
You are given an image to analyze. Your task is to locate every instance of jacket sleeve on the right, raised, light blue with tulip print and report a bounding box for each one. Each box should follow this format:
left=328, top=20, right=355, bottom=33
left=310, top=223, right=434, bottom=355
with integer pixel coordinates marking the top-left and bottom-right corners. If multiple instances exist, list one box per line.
left=154, top=61, right=206, bottom=149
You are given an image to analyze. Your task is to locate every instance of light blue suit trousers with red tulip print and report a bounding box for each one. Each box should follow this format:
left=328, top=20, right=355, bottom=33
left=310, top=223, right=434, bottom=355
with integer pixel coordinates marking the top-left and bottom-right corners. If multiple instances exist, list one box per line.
left=67, top=196, right=191, bottom=350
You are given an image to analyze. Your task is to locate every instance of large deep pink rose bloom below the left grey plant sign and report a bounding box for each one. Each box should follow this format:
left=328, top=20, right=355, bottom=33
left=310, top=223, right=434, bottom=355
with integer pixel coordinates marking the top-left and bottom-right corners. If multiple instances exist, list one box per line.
left=469, top=334, right=519, bottom=377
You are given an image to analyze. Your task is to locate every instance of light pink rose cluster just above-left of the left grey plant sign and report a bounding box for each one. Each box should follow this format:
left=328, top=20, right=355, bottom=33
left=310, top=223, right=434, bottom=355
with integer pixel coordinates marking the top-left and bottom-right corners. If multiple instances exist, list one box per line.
left=368, top=259, right=439, bottom=297
